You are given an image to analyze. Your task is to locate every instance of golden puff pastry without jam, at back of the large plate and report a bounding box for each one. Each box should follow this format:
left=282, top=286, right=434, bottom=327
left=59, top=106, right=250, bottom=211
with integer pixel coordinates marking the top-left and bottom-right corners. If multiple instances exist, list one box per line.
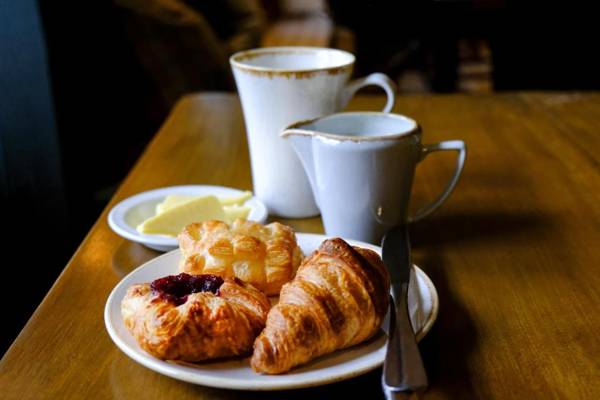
left=178, top=219, right=303, bottom=295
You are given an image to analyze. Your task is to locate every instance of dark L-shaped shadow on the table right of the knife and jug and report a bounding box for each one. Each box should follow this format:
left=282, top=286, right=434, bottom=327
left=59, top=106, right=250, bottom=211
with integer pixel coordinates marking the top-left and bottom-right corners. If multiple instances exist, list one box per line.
left=404, top=211, right=557, bottom=398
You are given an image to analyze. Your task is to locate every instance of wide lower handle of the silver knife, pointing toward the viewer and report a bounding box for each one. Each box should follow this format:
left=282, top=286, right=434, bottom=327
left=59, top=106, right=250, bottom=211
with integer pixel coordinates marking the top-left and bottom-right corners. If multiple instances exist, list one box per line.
left=382, top=283, right=427, bottom=392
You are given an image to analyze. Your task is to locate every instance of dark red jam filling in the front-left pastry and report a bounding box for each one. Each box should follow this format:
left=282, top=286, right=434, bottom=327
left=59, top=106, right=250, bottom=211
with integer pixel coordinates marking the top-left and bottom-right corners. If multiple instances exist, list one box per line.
left=150, top=273, right=223, bottom=306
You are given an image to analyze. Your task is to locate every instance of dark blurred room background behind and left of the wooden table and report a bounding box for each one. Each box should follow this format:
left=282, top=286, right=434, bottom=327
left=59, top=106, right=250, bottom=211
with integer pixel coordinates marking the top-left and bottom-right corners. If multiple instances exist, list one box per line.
left=0, top=0, right=600, bottom=354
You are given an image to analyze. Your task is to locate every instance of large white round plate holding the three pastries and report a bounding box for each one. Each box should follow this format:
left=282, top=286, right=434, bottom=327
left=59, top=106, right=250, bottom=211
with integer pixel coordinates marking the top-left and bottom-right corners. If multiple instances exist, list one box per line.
left=104, top=233, right=438, bottom=390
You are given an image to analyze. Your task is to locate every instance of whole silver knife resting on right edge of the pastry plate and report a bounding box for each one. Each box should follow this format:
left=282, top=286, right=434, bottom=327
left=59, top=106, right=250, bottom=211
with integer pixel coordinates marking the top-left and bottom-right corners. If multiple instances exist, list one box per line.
left=381, top=225, right=427, bottom=398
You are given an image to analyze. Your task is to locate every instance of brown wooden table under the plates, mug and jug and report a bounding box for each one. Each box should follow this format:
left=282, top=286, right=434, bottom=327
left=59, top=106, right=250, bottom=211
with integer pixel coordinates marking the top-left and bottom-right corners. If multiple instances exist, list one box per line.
left=0, top=93, right=600, bottom=400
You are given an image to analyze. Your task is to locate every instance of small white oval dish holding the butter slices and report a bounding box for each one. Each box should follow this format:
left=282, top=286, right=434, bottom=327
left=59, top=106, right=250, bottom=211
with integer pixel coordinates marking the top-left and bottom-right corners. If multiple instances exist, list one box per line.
left=108, top=185, right=269, bottom=251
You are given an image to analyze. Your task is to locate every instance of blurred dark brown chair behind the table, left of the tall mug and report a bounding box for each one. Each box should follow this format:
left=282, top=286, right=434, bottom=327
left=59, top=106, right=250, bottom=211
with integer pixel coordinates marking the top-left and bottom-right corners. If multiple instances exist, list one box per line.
left=115, top=0, right=264, bottom=107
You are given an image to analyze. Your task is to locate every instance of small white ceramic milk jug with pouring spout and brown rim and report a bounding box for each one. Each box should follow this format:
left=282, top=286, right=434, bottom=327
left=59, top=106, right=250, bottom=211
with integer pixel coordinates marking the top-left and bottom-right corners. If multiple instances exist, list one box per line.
left=281, top=112, right=466, bottom=243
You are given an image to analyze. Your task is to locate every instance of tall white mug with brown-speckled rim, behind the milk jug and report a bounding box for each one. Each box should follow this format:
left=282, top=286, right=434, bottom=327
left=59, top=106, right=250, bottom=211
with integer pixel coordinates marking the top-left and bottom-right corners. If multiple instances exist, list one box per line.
left=230, top=47, right=396, bottom=218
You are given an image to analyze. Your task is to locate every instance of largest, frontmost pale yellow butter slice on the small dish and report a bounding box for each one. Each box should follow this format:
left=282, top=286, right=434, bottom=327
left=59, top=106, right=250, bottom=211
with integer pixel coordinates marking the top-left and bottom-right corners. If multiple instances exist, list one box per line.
left=137, top=196, right=226, bottom=236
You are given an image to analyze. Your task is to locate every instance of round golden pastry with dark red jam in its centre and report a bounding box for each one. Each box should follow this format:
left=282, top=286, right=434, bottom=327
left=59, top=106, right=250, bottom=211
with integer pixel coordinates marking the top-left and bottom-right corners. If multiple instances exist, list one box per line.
left=121, top=274, right=270, bottom=362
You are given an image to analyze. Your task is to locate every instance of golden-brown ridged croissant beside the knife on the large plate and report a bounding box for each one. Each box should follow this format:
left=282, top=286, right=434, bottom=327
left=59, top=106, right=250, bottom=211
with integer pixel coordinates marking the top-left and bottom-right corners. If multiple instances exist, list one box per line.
left=251, top=238, right=390, bottom=374
